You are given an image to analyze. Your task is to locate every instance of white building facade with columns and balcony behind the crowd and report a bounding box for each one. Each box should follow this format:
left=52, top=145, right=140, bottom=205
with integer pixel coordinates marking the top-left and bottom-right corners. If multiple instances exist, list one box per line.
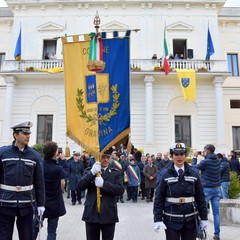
left=0, top=0, right=240, bottom=153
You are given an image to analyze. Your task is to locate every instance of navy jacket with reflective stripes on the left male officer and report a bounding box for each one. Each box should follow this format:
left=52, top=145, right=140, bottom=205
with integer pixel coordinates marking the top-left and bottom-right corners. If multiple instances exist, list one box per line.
left=0, top=141, right=45, bottom=208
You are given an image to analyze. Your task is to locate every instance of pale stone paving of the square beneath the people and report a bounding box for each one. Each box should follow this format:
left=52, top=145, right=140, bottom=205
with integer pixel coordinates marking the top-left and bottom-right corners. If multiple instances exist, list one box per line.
left=13, top=194, right=240, bottom=240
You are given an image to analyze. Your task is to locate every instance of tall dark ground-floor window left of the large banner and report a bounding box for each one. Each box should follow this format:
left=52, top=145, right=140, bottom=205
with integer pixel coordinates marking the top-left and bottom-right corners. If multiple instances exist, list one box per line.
left=37, top=115, right=53, bottom=143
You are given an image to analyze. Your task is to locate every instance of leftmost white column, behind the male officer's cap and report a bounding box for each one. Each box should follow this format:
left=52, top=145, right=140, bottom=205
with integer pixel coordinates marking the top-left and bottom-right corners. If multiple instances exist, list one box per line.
left=2, top=76, right=16, bottom=145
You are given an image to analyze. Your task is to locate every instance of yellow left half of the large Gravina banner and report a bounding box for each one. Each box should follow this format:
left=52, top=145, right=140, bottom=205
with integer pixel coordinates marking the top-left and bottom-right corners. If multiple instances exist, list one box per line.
left=63, top=41, right=100, bottom=153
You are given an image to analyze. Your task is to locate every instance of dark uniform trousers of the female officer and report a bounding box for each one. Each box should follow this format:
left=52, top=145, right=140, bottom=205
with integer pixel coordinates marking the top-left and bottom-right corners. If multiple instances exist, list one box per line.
left=165, top=227, right=196, bottom=240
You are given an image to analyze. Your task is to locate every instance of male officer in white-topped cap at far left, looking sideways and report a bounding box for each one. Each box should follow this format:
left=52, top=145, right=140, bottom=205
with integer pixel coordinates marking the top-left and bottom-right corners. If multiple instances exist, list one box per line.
left=0, top=121, right=45, bottom=240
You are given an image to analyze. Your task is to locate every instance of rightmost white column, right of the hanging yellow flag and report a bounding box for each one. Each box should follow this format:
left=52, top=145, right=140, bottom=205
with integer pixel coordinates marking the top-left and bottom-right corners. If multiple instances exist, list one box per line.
left=213, top=76, right=226, bottom=152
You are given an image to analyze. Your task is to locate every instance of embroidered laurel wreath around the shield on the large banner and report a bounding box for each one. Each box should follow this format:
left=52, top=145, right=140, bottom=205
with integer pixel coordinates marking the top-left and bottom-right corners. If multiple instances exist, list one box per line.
left=76, top=84, right=120, bottom=126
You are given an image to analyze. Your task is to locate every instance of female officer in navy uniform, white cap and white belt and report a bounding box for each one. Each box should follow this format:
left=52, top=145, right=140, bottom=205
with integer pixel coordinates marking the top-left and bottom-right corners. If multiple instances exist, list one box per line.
left=153, top=143, right=208, bottom=240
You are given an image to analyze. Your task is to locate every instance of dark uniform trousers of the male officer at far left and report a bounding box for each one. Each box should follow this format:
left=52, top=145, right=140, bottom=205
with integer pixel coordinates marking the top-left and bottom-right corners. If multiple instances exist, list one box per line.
left=0, top=213, right=33, bottom=240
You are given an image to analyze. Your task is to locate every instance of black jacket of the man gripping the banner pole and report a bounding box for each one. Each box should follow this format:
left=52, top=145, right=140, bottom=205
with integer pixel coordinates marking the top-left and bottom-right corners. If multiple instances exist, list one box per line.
left=77, top=168, right=124, bottom=224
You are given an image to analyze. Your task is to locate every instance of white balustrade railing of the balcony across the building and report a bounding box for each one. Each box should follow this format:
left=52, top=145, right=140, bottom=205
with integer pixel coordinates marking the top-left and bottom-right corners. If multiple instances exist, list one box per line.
left=0, top=59, right=228, bottom=74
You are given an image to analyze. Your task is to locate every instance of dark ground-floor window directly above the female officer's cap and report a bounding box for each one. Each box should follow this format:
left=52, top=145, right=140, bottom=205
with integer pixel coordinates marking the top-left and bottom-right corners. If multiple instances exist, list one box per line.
left=175, top=116, right=192, bottom=147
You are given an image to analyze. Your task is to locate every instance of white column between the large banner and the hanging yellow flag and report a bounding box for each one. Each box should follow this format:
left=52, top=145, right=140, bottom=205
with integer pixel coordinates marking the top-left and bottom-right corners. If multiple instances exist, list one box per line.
left=144, top=75, right=154, bottom=153
